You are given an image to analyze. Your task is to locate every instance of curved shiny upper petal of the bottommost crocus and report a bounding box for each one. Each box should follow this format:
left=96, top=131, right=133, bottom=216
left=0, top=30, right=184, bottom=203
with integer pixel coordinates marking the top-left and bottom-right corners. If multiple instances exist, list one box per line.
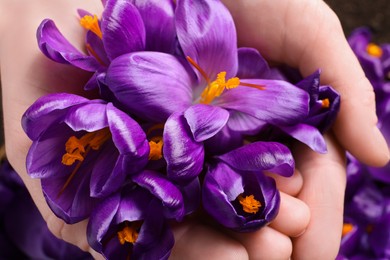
left=132, top=170, right=184, bottom=221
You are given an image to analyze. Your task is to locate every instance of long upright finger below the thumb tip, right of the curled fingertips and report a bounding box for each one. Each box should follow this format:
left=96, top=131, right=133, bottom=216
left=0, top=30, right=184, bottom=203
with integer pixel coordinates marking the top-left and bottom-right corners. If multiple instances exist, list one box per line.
left=293, top=133, right=346, bottom=259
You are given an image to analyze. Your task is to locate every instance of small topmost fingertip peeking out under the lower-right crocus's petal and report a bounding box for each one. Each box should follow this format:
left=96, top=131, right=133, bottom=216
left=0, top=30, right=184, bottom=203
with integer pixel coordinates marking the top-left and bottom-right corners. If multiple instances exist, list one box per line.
left=265, top=169, right=303, bottom=196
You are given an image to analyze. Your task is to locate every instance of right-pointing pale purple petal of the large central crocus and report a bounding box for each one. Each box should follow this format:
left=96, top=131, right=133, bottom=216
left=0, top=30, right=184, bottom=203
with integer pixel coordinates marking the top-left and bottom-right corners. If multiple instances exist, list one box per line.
left=214, top=79, right=309, bottom=125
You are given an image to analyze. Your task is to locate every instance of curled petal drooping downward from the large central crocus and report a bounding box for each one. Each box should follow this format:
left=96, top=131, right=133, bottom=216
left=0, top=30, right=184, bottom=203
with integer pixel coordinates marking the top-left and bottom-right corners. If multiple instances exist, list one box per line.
left=163, top=113, right=204, bottom=182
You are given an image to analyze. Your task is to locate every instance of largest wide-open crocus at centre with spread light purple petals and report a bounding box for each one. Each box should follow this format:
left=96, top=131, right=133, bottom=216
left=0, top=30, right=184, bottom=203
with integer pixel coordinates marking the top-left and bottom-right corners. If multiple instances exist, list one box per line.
left=101, top=0, right=309, bottom=182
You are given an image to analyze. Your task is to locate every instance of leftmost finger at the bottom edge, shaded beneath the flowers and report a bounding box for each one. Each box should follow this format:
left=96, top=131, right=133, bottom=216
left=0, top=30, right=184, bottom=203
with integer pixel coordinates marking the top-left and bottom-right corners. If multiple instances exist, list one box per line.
left=169, top=222, right=248, bottom=260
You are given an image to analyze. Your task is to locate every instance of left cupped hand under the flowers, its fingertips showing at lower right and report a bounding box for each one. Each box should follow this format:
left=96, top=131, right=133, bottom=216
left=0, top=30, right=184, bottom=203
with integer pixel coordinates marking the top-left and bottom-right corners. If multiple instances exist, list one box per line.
left=0, top=0, right=309, bottom=259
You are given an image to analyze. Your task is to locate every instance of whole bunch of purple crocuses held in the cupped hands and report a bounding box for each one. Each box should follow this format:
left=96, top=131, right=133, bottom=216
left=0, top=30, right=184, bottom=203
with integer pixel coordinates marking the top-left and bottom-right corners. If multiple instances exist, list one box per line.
left=22, top=0, right=340, bottom=259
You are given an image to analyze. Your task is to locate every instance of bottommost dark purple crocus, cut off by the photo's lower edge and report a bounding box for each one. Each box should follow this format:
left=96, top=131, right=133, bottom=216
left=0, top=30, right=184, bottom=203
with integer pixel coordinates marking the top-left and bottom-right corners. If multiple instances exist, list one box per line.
left=87, top=171, right=190, bottom=259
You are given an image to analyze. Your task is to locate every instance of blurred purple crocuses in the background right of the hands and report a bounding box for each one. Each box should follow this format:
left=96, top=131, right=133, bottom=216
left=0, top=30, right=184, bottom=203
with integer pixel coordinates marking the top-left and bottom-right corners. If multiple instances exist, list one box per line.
left=338, top=28, right=390, bottom=260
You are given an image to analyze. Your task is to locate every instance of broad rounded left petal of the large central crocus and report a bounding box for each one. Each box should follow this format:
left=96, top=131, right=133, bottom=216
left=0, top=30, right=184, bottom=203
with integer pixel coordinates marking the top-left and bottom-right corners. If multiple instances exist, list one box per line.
left=104, top=52, right=192, bottom=122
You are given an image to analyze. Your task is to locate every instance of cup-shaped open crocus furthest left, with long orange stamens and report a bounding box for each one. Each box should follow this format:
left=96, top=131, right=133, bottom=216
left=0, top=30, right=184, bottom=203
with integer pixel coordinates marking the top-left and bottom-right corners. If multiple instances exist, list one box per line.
left=22, top=94, right=149, bottom=223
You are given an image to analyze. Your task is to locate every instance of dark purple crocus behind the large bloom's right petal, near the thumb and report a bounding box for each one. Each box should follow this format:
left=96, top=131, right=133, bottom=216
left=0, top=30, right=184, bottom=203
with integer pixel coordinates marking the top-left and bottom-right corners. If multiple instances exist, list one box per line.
left=237, top=48, right=340, bottom=153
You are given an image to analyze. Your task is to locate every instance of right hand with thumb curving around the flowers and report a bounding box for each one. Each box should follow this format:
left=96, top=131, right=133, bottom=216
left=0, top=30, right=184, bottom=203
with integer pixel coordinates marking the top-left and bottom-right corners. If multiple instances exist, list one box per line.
left=223, top=0, right=389, bottom=259
